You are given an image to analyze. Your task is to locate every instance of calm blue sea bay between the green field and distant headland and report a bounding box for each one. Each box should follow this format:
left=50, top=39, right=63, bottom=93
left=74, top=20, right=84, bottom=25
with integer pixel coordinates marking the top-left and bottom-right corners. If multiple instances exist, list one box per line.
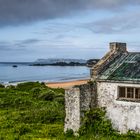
left=0, top=64, right=90, bottom=84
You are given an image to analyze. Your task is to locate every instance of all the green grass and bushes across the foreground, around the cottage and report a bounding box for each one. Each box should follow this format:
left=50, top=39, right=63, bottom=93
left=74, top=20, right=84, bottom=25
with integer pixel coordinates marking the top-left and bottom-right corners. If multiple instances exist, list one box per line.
left=0, top=82, right=140, bottom=140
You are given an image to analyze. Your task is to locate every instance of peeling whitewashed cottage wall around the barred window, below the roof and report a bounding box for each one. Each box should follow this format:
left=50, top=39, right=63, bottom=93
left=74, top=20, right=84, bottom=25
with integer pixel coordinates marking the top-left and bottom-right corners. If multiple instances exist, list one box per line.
left=97, top=82, right=140, bottom=133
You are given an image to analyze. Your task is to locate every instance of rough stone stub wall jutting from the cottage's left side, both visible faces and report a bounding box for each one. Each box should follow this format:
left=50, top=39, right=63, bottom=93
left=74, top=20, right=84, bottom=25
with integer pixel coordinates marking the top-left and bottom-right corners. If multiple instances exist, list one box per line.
left=64, top=84, right=96, bottom=132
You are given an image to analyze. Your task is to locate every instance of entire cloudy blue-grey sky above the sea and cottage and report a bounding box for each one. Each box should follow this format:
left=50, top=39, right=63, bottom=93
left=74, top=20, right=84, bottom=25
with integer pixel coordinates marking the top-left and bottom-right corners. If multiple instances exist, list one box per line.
left=0, top=0, right=140, bottom=61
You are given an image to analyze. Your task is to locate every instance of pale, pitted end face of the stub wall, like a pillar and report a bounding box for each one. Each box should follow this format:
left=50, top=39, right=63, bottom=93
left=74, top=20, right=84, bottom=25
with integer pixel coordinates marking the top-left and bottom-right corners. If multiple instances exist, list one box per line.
left=64, top=87, right=80, bottom=132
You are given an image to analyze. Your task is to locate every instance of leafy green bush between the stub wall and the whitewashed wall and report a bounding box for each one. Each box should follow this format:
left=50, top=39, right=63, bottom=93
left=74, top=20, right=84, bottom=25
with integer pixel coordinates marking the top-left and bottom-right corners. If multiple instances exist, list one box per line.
left=79, top=108, right=115, bottom=135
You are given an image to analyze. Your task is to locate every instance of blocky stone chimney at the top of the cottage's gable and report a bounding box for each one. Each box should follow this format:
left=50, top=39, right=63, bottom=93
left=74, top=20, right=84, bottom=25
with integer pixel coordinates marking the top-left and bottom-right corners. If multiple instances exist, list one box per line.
left=110, top=42, right=127, bottom=53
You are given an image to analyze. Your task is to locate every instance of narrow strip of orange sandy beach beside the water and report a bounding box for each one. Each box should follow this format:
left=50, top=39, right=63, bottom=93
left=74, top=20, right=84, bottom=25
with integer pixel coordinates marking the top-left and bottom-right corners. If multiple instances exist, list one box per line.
left=46, top=79, right=89, bottom=89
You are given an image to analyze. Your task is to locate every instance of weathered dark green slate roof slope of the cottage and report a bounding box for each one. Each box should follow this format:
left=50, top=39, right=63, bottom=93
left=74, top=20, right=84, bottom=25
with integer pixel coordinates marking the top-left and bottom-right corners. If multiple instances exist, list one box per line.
left=98, top=52, right=140, bottom=82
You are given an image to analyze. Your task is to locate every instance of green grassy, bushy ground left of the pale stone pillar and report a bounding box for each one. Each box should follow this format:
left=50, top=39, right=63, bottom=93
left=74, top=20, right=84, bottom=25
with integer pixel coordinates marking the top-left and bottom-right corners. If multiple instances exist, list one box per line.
left=0, top=82, right=65, bottom=140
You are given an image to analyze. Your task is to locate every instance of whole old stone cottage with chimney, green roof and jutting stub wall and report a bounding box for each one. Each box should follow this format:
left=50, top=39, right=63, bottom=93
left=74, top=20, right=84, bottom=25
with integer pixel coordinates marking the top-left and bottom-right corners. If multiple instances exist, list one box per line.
left=65, top=42, right=140, bottom=133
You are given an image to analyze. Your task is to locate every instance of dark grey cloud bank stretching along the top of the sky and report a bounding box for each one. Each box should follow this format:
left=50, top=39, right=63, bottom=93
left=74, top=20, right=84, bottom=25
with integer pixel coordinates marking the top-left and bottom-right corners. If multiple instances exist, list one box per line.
left=0, top=0, right=140, bottom=26
